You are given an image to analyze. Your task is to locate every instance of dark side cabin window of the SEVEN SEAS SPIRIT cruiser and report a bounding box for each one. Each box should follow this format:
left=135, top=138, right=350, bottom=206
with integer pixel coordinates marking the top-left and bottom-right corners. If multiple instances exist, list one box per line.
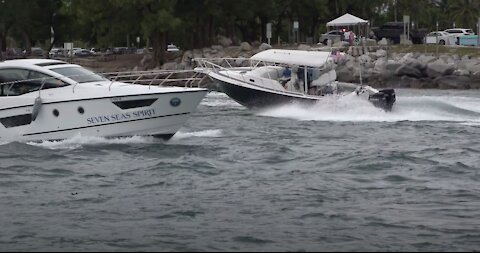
left=0, top=69, right=68, bottom=96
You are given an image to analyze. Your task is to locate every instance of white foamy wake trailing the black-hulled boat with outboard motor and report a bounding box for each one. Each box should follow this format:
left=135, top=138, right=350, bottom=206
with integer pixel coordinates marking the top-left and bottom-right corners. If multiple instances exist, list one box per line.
left=258, top=95, right=480, bottom=125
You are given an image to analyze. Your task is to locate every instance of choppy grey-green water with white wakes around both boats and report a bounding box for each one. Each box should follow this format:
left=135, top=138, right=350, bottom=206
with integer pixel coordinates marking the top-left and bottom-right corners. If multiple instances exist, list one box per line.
left=0, top=90, right=480, bottom=251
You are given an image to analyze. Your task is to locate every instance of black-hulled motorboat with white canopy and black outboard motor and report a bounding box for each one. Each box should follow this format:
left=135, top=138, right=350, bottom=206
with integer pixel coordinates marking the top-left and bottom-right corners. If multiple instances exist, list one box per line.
left=194, top=49, right=396, bottom=111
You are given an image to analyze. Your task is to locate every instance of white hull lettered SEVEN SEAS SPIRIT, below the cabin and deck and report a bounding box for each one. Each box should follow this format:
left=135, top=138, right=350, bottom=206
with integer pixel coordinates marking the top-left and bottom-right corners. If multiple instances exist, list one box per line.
left=0, top=90, right=208, bottom=141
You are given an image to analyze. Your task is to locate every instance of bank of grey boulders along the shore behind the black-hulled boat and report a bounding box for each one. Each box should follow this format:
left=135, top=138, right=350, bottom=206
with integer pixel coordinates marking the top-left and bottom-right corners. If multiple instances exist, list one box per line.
left=134, top=39, right=480, bottom=89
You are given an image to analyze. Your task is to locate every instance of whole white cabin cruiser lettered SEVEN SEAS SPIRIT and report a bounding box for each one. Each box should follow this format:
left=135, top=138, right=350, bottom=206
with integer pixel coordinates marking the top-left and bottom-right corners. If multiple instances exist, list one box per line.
left=0, top=59, right=208, bottom=141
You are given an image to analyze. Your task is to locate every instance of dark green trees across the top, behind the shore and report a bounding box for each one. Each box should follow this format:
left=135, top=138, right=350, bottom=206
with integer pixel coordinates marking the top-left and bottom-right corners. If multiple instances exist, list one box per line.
left=0, top=0, right=480, bottom=63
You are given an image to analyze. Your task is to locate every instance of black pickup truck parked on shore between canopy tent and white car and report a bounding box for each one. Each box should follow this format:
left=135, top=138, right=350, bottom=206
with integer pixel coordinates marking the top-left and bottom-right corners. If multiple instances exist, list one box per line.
left=372, top=22, right=428, bottom=44
